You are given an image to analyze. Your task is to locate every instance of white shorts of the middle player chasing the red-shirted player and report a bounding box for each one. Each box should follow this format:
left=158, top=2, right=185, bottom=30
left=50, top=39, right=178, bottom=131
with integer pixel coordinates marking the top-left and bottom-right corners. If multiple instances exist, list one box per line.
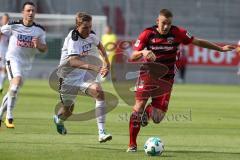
left=59, top=72, right=97, bottom=106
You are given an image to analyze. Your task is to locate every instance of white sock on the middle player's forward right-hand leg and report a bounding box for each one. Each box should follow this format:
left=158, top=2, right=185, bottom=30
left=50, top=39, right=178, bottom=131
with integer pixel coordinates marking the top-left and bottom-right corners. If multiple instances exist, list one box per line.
left=95, top=100, right=106, bottom=134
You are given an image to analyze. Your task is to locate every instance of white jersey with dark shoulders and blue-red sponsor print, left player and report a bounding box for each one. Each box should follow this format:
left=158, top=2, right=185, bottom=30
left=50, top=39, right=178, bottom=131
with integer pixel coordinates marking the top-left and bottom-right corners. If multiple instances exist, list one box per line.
left=1, top=20, right=46, bottom=68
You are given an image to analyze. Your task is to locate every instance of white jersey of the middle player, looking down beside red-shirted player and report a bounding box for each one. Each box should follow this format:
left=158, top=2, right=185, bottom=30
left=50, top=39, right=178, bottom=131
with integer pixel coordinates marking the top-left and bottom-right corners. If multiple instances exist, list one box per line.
left=58, top=30, right=100, bottom=79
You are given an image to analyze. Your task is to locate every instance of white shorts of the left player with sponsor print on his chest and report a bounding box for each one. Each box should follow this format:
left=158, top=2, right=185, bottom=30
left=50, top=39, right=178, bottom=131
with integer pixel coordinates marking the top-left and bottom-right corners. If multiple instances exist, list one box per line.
left=6, top=59, right=29, bottom=80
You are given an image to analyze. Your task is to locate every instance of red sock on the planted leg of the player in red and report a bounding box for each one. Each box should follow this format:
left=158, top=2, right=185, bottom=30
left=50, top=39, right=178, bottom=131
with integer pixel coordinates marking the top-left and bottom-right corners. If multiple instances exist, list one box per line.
left=129, top=111, right=141, bottom=147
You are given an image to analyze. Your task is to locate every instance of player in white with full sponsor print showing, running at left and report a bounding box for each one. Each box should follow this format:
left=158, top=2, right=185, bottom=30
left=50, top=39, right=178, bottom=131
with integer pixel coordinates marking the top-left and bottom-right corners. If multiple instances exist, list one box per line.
left=0, top=2, right=47, bottom=128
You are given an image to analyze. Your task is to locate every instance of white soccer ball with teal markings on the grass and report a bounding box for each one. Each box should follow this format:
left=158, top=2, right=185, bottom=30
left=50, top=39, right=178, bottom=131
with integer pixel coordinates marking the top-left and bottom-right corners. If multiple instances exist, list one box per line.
left=144, top=137, right=164, bottom=156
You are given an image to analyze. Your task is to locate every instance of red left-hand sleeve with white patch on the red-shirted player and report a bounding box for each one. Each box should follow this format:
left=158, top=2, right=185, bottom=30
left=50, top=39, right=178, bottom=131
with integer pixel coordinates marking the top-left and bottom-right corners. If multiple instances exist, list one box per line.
left=133, top=30, right=150, bottom=51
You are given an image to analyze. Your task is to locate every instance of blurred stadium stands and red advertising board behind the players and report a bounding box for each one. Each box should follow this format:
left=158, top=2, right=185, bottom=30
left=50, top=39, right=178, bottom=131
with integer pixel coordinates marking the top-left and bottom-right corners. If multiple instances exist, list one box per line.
left=0, top=0, right=240, bottom=84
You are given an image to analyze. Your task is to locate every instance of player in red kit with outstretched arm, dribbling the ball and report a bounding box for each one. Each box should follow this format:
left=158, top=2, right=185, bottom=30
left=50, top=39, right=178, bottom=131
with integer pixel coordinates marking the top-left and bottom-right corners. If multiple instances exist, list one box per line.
left=127, top=9, right=235, bottom=152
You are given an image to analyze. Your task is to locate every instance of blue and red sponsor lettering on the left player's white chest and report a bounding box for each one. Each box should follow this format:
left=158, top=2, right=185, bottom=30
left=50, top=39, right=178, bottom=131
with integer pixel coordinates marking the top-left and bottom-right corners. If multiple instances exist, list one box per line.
left=17, top=34, right=34, bottom=48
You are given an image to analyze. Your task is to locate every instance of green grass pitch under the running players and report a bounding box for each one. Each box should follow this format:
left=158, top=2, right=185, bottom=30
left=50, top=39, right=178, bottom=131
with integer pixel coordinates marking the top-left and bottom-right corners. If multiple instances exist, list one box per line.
left=0, top=80, right=240, bottom=160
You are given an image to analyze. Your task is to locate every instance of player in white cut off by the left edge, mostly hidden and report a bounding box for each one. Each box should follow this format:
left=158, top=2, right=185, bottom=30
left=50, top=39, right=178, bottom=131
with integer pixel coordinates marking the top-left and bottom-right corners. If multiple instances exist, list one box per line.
left=0, top=13, right=9, bottom=93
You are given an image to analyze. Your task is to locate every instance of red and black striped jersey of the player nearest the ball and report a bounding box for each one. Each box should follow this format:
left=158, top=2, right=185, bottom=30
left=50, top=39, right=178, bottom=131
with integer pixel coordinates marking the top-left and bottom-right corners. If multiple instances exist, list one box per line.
left=133, top=26, right=194, bottom=79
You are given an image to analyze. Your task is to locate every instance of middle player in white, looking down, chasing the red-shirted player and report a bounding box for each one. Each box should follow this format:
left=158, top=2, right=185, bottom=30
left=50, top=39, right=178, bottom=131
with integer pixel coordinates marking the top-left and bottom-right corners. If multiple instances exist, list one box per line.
left=54, top=12, right=112, bottom=143
